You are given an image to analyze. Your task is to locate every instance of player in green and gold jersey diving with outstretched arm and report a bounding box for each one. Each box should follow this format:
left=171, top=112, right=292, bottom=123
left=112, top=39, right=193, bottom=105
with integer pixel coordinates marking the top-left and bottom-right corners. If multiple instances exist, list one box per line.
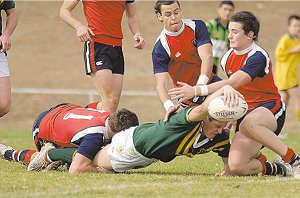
left=1, top=86, right=241, bottom=175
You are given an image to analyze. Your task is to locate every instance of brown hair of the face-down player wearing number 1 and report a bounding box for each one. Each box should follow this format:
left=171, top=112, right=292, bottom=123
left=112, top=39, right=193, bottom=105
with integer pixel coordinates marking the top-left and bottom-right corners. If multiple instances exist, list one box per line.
left=108, top=108, right=139, bottom=133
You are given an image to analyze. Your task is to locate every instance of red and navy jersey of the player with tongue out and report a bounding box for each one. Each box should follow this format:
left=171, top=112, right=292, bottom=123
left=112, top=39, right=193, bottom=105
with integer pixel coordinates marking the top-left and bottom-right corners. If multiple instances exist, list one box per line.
left=152, top=19, right=211, bottom=87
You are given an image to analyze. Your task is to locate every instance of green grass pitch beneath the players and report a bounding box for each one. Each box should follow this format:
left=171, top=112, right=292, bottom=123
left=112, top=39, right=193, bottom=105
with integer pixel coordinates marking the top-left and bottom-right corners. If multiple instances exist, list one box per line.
left=0, top=131, right=300, bottom=197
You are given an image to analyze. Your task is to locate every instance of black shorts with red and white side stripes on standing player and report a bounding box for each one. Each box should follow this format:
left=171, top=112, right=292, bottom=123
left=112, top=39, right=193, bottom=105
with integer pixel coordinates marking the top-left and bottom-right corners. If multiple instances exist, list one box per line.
left=84, top=41, right=124, bottom=75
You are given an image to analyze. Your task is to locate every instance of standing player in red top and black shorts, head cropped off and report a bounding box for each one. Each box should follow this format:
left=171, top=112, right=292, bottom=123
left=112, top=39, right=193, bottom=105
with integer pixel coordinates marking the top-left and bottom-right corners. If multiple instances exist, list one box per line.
left=60, top=0, right=145, bottom=112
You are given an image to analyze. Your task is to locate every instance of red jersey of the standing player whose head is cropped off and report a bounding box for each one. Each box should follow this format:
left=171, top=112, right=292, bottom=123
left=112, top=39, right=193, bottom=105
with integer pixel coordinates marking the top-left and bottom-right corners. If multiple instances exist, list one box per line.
left=83, top=0, right=134, bottom=46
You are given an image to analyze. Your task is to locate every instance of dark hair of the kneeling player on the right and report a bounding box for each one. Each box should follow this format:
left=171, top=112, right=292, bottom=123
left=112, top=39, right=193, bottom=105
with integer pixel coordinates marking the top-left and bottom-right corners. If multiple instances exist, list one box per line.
left=230, top=11, right=260, bottom=41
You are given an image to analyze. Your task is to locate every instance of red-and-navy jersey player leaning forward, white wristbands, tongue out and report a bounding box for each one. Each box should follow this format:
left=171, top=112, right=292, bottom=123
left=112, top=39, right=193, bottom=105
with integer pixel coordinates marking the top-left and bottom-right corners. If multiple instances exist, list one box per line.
left=152, top=0, right=220, bottom=111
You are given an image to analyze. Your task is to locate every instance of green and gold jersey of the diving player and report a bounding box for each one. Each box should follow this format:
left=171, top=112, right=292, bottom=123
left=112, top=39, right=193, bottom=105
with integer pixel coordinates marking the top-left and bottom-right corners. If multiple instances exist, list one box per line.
left=133, top=107, right=230, bottom=162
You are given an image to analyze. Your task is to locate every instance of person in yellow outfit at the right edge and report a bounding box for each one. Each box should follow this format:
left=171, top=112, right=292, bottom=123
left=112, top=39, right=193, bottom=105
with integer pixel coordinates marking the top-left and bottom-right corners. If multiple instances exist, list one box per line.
left=275, top=15, right=300, bottom=121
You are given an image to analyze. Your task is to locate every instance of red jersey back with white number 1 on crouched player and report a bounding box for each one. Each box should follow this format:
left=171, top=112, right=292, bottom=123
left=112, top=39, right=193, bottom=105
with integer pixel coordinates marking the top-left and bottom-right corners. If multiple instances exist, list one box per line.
left=37, top=104, right=110, bottom=147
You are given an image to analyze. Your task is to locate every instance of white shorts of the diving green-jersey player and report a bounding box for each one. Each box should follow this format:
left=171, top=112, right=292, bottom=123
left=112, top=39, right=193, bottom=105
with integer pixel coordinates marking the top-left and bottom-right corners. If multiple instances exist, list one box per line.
left=108, top=127, right=158, bottom=172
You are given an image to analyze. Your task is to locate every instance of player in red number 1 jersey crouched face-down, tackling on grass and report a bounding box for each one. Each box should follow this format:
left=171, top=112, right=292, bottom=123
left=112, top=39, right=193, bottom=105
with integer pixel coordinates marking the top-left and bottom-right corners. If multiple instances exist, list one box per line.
left=0, top=104, right=139, bottom=173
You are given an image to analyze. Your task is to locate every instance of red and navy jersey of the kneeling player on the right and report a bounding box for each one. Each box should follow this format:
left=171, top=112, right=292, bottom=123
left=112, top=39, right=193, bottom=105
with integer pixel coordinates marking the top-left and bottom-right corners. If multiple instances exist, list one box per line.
left=221, top=43, right=281, bottom=113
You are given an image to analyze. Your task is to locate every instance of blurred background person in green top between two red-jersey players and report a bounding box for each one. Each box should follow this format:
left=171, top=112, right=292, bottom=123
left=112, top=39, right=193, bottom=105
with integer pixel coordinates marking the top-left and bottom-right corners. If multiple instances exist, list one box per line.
left=206, top=1, right=235, bottom=74
